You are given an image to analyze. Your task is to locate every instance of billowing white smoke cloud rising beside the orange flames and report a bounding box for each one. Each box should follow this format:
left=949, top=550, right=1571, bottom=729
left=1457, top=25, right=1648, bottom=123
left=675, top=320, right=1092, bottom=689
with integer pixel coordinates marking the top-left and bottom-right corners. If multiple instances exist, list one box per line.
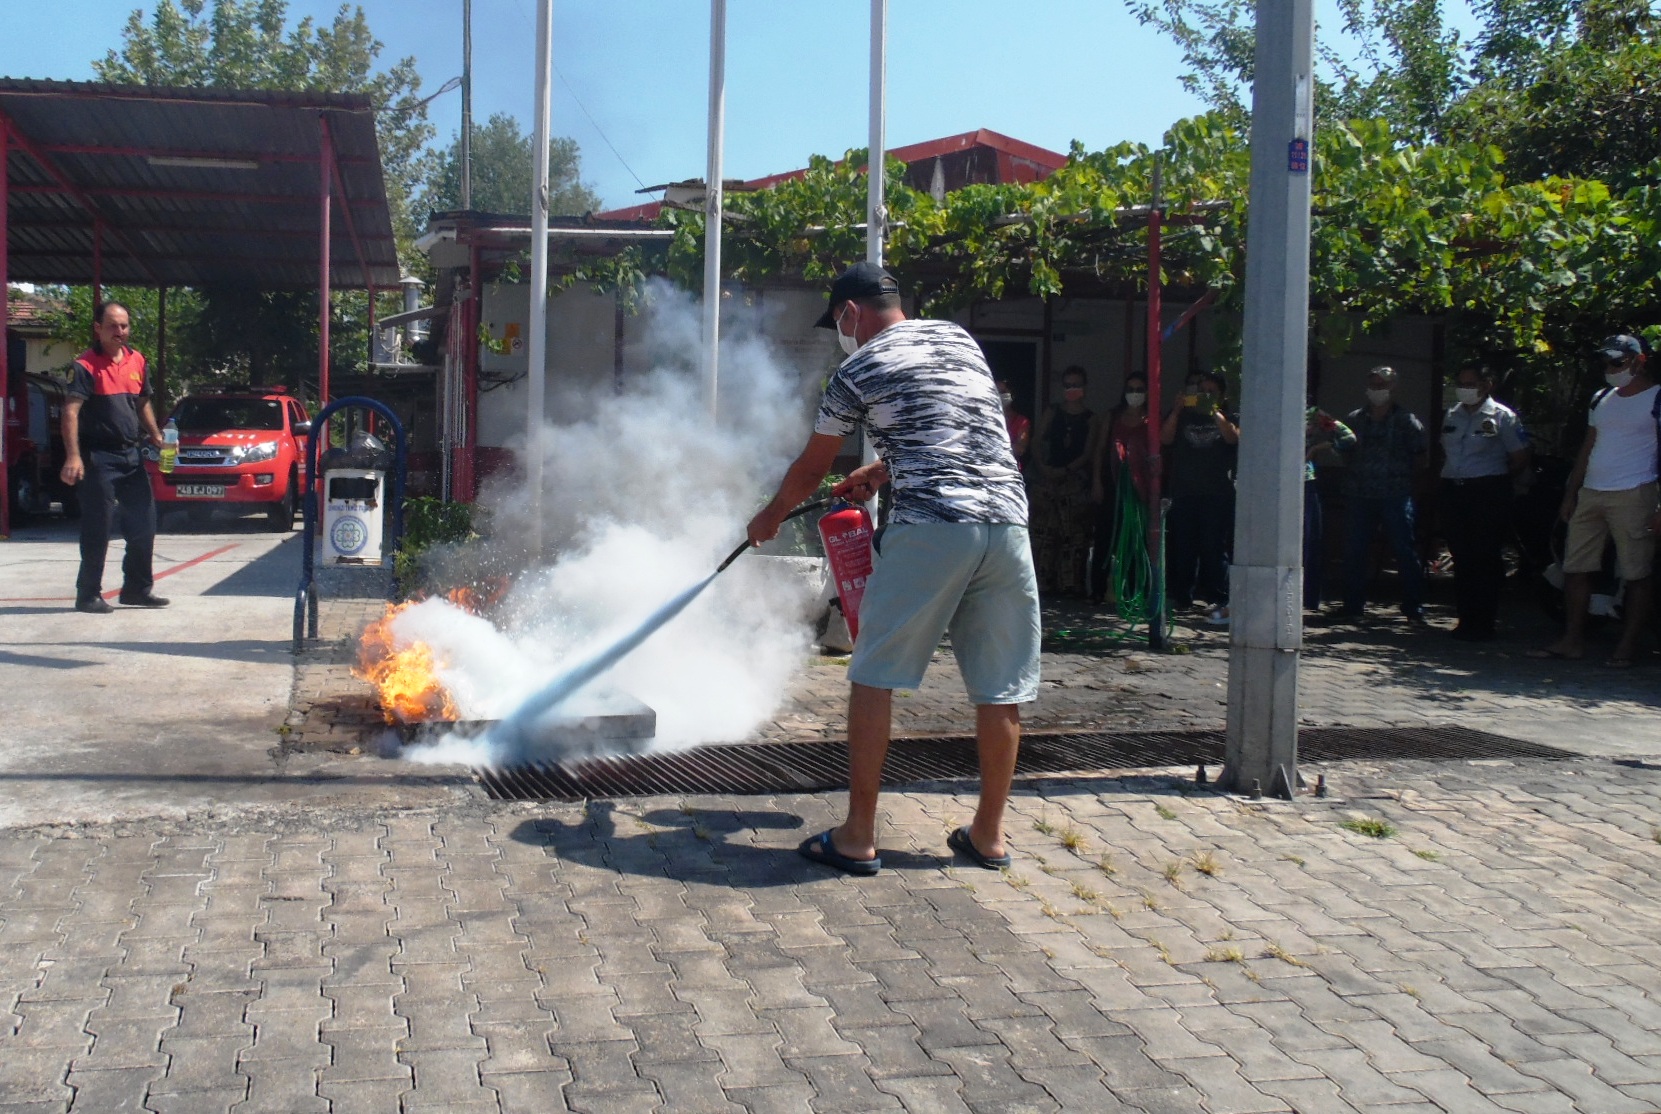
left=394, top=284, right=837, bottom=762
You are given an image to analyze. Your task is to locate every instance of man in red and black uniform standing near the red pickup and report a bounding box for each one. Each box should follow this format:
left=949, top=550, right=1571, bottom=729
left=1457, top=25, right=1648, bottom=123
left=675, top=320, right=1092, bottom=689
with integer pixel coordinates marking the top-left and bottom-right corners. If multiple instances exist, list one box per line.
left=63, top=302, right=168, bottom=614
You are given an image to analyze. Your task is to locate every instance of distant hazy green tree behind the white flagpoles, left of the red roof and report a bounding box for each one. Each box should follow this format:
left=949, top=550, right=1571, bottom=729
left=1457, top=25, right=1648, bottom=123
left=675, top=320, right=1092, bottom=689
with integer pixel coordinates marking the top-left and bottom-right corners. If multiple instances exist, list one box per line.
left=422, top=113, right=601, bottom=216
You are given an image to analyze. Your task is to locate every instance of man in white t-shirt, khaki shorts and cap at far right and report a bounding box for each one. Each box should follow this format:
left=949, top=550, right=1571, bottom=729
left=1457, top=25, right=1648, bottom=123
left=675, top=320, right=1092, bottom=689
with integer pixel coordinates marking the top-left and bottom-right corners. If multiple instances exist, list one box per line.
left=1531, top=335, right=1661, bottom=667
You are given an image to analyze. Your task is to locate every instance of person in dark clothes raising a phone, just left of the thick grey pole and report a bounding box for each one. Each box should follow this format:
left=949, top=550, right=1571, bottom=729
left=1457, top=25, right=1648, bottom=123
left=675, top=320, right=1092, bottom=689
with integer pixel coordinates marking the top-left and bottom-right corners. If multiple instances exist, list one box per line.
left=1159, top=372, right=1241, bottom=614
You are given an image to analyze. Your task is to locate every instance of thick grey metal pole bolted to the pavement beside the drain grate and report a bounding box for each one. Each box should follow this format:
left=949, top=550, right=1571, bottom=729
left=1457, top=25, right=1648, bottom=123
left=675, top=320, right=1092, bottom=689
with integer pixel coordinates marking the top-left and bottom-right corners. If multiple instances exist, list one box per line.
left=1221, top=0, right=1314, bottom=797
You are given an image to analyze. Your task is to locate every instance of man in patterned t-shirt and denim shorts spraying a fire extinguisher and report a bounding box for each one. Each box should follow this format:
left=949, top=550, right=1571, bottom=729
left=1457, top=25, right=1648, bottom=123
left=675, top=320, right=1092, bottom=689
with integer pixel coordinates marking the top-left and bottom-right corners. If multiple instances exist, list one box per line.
left=749, top=262, right=1040, bottom=875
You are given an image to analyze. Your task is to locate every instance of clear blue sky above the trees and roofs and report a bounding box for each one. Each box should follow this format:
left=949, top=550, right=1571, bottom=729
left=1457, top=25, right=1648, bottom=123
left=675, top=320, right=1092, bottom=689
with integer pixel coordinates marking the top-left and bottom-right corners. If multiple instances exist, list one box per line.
left=0, top=0, right=1222, bottom=206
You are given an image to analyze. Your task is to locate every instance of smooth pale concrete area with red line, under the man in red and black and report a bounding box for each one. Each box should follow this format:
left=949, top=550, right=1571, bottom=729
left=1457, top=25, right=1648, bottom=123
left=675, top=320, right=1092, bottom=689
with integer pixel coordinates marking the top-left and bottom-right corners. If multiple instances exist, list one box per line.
left=0, top=515, right=455, bottom=825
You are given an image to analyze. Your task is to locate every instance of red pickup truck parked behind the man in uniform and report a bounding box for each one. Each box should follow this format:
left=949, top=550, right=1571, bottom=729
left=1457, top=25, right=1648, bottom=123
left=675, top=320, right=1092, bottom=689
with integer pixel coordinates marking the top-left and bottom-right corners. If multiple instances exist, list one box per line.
left=148, top=387, right=311, bottom=531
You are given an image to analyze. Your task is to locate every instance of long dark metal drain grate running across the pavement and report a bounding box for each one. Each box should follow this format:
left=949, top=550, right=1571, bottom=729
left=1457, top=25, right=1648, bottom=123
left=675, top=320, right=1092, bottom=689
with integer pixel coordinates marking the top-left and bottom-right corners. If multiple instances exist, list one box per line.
left=473, top=727, right=1578, bottom=800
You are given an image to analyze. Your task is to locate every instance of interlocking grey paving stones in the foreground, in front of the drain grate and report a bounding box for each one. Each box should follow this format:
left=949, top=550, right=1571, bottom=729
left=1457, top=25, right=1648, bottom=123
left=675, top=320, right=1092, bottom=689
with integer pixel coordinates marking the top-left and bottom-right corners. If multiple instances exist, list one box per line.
left=0, top=759, right=1661, bottom=1114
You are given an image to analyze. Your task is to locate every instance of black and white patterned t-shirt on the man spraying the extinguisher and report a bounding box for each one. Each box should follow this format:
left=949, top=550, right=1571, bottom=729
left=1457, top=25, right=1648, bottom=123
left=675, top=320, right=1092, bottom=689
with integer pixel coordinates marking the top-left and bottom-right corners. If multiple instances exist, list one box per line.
left=814, top=320, right=1026, bottom=526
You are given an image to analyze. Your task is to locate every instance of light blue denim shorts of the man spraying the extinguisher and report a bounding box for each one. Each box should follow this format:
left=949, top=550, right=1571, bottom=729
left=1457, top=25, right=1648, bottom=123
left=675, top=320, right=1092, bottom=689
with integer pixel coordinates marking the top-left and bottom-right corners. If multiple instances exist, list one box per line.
left=847, top=523, right=1041, bottom=704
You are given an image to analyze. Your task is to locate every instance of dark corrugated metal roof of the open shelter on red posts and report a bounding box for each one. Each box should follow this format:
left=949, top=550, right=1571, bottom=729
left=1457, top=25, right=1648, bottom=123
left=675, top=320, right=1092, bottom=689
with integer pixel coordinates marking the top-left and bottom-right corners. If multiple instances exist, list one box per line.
left=0, top=78, right=399, bottom=289
